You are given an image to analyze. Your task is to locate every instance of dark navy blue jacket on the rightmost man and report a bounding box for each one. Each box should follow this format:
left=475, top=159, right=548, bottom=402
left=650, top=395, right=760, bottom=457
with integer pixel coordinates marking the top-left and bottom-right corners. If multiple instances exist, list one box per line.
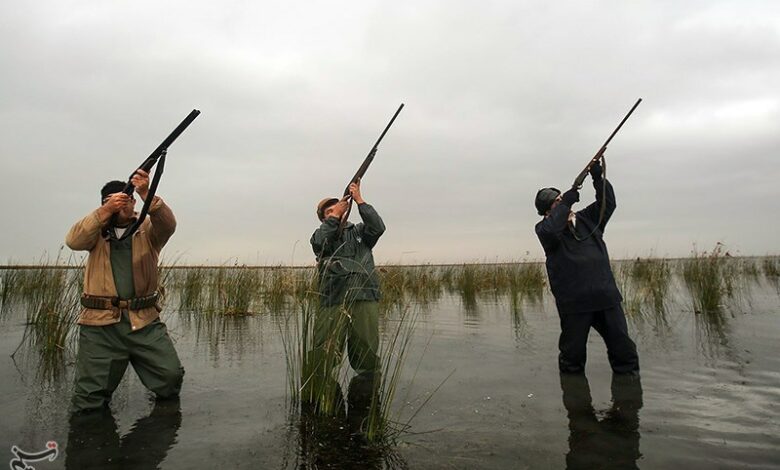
left=536, top=178, right=623, bottom=314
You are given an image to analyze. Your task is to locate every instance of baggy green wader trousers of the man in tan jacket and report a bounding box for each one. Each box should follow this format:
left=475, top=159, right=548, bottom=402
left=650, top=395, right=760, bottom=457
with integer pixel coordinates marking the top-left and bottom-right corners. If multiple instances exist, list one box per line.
left=72, top=313, right=184, bottom=411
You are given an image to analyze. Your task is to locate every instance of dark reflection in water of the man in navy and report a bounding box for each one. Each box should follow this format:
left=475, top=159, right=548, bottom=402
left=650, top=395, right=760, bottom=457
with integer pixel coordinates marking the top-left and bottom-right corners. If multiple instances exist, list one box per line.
left=561, top=374, right=642, bottom=470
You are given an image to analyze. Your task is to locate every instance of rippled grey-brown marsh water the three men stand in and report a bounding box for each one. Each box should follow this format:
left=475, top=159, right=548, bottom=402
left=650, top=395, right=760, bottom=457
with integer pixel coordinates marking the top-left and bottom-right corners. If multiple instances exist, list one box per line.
left=0, top=274, right=780, bottom=469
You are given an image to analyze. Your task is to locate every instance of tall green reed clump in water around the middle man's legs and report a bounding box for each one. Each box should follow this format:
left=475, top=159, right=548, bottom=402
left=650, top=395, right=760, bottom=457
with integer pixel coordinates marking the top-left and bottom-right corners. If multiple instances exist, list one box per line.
left=279, top=264, right=426, bottom=447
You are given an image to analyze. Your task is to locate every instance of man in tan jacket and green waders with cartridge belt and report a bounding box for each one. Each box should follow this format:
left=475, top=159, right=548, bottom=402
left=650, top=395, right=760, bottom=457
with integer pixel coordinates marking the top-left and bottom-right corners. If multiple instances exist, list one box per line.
left=65, top=170, right=184, bottom=411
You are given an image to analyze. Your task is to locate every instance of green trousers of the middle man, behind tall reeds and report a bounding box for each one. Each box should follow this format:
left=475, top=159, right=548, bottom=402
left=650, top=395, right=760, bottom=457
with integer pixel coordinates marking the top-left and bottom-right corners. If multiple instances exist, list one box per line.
left=301, top=301, right=381, bottom=414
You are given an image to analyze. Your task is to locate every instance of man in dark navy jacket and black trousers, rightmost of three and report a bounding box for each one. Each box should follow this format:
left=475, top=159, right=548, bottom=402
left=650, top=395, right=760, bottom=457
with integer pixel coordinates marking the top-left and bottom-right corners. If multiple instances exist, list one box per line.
left=535, top=163, right=639, bottom=374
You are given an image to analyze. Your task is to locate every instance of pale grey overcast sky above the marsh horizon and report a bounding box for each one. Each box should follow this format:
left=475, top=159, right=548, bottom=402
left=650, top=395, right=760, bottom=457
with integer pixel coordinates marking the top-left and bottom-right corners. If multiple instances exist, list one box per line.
left=0, top=0, right=780, bottom=264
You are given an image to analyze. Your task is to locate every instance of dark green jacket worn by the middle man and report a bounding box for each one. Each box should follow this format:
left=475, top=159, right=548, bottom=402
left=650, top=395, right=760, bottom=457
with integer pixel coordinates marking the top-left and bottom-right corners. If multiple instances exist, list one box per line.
left=311, top=203, right=385, bottom=307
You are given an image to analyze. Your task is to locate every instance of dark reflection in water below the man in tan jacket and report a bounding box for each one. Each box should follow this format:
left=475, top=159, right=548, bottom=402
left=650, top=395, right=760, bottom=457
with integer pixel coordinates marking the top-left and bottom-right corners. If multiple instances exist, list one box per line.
left=65, top=399, right=181, bottom=470
